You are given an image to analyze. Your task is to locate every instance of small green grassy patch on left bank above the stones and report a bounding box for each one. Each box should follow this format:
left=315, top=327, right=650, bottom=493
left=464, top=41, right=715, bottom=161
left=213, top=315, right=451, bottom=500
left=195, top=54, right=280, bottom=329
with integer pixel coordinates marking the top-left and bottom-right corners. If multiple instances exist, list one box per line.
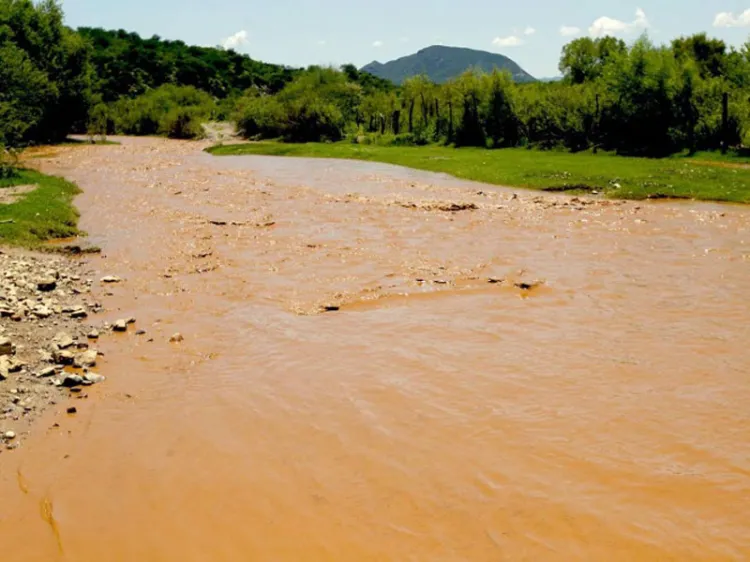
left=0, top=166, right=80, bottom=247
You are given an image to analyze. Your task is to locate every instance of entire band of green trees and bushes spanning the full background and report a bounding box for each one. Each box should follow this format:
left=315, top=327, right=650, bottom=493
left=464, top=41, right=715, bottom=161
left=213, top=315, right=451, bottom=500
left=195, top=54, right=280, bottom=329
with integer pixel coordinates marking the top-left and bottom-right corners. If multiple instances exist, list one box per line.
left=0, top=0, right=750, bottom=156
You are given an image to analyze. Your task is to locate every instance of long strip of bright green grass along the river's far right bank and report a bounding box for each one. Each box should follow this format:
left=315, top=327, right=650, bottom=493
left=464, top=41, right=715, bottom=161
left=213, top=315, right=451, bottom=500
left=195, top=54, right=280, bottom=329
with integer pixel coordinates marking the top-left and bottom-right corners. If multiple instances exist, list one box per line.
left=208, top=142, right=750, bottom=203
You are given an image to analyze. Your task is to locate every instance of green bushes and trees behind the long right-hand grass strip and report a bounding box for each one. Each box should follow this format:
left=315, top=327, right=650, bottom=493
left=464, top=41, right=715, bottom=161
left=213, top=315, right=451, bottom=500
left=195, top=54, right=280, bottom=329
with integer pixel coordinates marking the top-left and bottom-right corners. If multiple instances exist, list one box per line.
left=237, top=35, right=750, bottom=160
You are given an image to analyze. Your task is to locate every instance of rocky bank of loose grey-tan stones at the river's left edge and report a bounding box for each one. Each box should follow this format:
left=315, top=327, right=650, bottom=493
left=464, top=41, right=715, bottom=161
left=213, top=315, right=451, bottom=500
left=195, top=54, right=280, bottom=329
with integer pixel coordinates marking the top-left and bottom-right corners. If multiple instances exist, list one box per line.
left=0, top=248, right=112, bottom=451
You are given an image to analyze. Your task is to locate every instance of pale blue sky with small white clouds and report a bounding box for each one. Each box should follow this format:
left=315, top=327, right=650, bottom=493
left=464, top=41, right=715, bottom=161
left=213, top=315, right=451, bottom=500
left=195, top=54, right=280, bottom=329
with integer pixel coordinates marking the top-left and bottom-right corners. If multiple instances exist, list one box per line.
left=62, top=0, right=750, bottom=78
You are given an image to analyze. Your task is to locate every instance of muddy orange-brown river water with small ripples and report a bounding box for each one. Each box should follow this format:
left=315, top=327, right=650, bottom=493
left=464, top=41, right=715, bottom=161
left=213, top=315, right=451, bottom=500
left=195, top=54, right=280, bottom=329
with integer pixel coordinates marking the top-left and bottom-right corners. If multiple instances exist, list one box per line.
left=0, top=139, right=750, bottom=562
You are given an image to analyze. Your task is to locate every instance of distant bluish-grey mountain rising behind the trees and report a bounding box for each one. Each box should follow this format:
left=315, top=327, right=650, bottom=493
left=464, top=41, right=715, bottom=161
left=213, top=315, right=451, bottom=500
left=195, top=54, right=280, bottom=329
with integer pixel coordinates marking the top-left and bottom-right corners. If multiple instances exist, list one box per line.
left=362, top=45, right=535, bottom=84
